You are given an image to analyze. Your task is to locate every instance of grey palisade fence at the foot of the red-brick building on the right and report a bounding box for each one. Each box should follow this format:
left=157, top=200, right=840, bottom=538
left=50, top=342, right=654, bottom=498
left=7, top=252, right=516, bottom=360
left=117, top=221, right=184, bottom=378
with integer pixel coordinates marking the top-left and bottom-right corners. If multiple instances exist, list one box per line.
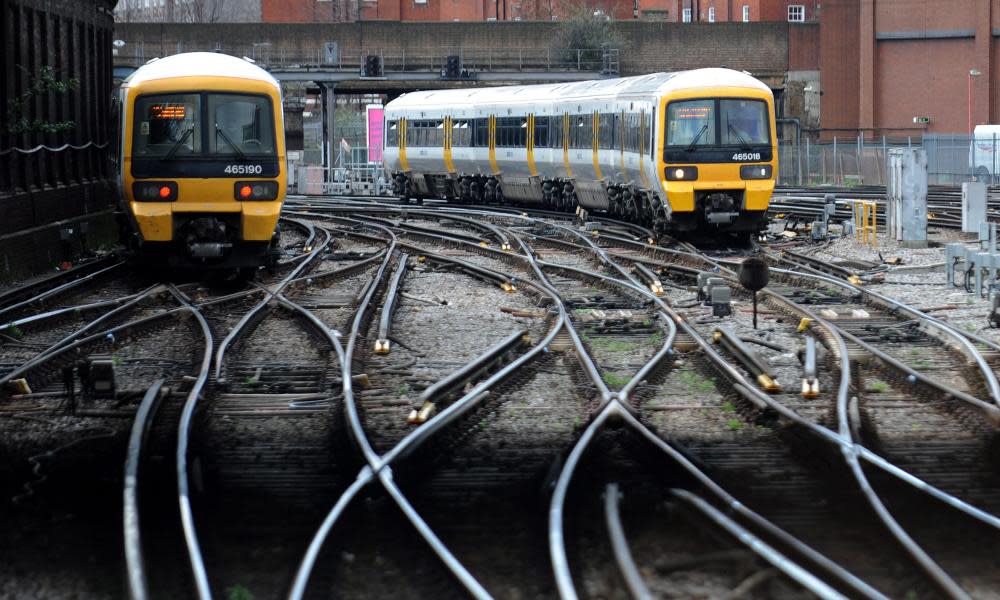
left=778, top=134, right=1000, bottom=187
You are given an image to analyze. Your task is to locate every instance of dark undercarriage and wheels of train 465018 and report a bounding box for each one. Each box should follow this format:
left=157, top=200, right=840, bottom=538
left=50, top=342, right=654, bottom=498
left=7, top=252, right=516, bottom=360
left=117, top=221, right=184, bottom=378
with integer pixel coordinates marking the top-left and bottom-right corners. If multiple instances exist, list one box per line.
left=393, top=173, right=767, bottom=238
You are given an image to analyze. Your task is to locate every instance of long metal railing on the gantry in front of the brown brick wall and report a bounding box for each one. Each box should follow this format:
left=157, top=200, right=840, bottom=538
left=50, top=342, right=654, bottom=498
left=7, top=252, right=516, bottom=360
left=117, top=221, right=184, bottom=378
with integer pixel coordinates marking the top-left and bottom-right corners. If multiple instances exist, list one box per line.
left=115, top=40, right=620, bottom=73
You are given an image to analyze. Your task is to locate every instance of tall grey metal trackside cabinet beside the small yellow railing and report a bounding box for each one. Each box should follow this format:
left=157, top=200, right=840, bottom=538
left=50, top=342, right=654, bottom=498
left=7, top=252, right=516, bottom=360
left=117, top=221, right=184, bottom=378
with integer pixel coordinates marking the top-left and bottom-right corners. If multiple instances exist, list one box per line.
left=886, top=148, right=927, bottom=248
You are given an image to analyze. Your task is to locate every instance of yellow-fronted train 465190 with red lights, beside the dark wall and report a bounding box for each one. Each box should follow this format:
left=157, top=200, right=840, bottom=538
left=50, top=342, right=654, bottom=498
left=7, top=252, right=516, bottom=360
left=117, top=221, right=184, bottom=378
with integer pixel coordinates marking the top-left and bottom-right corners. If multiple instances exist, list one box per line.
left=118, top=52, right=287, bottom=268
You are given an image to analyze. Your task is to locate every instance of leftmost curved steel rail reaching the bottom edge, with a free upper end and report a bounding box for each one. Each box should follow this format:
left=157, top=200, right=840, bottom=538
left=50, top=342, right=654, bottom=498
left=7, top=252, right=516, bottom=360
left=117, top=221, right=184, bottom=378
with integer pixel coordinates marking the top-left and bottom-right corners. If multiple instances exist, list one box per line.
left=122, top=379, right=164, bottom=600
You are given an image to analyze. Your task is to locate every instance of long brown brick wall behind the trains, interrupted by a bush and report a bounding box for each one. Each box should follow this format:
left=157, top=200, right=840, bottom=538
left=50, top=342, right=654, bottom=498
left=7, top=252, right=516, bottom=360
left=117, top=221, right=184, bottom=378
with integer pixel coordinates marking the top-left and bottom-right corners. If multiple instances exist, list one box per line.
left=115, top=21, right=788, bottom=75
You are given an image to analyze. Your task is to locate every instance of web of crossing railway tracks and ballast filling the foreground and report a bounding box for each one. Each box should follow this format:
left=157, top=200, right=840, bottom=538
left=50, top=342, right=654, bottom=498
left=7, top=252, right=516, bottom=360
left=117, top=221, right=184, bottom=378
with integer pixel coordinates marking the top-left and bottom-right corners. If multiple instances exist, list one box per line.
left=0, top=200, right=1000, bottom=599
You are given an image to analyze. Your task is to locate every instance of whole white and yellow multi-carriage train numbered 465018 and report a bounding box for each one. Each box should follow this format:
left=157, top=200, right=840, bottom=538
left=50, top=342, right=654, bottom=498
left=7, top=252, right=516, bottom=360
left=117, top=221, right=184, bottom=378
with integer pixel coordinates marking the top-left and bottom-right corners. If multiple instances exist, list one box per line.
left=383, top=69, right=778, bottom=232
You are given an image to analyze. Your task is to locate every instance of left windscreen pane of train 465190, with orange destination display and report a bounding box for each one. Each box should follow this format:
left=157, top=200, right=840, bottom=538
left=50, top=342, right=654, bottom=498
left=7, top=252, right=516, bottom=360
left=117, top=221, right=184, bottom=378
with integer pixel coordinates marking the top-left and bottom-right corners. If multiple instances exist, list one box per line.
left=132, top=94, right=202, bottom=158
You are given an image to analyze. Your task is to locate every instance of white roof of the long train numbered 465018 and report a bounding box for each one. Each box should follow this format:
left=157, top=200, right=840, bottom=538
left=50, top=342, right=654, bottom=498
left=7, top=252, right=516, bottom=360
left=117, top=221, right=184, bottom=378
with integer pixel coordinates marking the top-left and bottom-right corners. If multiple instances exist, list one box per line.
left=386, top=68, right=771, bottom=110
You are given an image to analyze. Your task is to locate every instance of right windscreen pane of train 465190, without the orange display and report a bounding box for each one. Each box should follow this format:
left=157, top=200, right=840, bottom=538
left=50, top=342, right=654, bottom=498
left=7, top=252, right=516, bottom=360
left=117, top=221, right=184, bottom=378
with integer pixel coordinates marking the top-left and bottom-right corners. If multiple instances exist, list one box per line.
left=208, top=94, right=276, bottom=156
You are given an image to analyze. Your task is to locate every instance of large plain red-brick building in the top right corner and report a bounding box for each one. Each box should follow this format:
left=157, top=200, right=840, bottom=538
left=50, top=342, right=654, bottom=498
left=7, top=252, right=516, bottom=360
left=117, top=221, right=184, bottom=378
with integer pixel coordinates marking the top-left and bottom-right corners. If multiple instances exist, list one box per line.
left=820, top=0, right=1000, bottom=137
